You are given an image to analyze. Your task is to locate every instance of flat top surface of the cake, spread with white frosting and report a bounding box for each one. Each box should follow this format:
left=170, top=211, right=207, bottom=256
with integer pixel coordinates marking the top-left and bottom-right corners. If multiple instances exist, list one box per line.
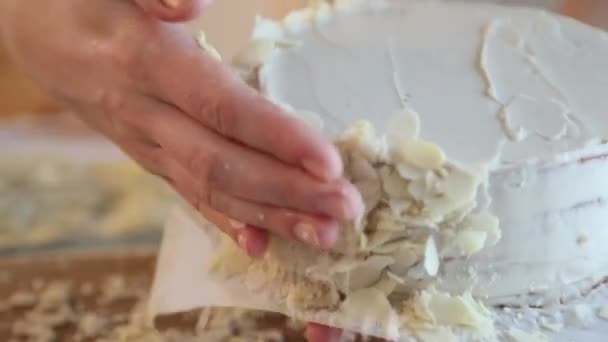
left=254, top=0, right=608, bottom=168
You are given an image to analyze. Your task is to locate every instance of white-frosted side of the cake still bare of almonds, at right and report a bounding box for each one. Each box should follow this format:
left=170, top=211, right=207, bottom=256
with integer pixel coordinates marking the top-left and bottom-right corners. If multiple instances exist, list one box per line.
left=440, top=147, right=608, bottom=306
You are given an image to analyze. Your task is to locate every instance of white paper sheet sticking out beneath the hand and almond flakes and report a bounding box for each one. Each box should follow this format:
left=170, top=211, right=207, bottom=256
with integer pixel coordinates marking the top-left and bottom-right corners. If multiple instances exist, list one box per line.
left=148, top=203, right=406, bottom=338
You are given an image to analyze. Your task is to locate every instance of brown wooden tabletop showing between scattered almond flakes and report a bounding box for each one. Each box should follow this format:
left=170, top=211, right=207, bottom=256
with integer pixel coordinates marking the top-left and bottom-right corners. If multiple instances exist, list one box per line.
left=0, top=246, right=312, bottom=342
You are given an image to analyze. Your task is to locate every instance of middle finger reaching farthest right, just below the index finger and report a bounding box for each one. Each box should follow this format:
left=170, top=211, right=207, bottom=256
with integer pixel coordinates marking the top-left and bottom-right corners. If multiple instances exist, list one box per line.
left=138, top=96, right=363, bottom=222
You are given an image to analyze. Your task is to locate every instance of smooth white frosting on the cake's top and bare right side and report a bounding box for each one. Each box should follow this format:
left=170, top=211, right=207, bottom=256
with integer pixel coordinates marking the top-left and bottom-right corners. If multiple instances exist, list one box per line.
left=255, top=0, right=608, bottom=304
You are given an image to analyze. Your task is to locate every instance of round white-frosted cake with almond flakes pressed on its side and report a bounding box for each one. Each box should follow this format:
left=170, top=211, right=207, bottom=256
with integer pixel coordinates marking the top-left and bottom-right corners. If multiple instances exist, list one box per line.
left=152, top=0, right=608, bottom=341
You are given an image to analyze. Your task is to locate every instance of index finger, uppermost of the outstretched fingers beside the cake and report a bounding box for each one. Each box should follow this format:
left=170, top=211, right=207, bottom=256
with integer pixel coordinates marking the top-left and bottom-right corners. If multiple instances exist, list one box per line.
left=144, top=31, right=342, bottom=180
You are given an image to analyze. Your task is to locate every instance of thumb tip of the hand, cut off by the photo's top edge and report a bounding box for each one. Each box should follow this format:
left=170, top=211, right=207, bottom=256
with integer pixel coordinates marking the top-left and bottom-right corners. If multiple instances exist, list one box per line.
left=134, top=0, right=212, bottom=21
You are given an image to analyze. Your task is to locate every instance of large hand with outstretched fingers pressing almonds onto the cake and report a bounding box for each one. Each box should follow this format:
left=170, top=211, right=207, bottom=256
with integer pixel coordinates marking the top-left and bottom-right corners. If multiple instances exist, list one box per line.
left=0, top=0, right=362, bottom=255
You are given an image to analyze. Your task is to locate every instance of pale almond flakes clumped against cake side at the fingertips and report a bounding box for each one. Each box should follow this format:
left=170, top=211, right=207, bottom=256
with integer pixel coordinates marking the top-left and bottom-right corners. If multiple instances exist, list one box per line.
left=211, top=110, right=501, bottom=336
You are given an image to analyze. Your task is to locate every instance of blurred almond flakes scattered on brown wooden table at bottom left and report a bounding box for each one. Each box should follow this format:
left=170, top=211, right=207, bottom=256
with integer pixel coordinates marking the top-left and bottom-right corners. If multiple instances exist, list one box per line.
left=0, top=275, right=304, bottom=342
